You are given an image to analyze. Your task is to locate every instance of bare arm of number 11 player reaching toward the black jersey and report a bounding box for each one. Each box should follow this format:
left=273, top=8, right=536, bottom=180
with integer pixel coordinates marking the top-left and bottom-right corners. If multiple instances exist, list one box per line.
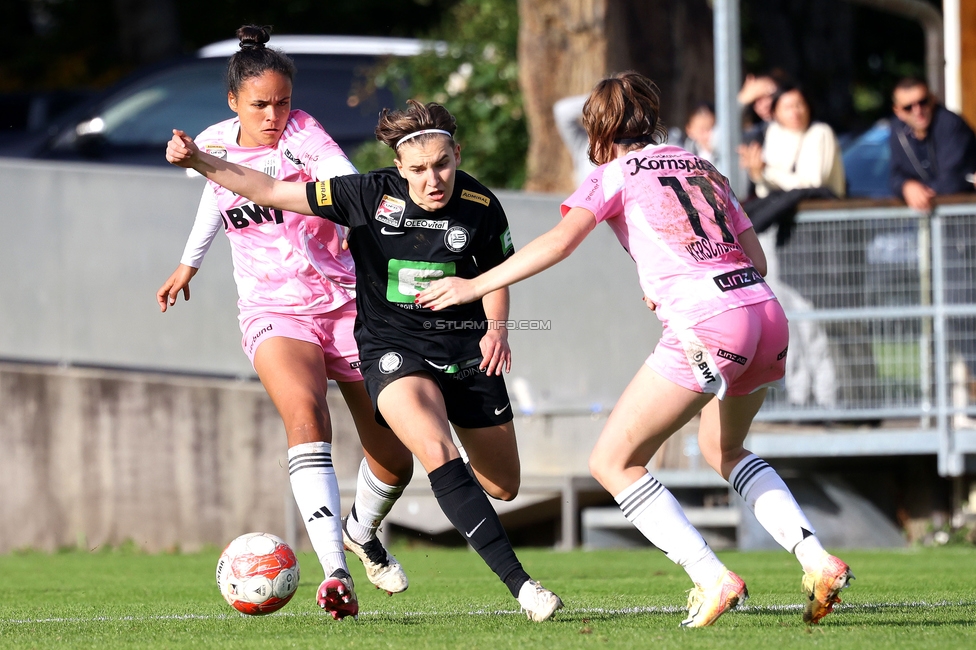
left=419, top=208, right=596, bottom=311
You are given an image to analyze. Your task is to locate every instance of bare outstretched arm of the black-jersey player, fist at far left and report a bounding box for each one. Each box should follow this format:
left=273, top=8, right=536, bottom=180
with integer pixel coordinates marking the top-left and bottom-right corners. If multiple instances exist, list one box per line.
left=166, top=129, right=314, bottom=215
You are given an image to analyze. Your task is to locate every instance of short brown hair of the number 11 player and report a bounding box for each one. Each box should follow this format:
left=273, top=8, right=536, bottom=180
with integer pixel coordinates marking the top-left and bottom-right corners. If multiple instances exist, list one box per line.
left=583, top=71, right=668, bottom=165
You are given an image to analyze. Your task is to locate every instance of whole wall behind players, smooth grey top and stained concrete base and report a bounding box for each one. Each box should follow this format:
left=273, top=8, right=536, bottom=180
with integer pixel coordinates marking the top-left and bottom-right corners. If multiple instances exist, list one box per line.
left=0, top=160, right=660, bottom=552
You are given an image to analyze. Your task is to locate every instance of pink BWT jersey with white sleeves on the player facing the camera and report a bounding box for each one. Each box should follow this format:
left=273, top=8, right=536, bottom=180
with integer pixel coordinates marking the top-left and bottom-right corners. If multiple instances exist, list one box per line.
left=191, top=110, right=356, bottom=320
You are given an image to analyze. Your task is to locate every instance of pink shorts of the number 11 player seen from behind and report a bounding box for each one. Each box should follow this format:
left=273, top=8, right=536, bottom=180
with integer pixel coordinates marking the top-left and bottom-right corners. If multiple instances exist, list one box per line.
left=644, top=300, right=790, bottom=399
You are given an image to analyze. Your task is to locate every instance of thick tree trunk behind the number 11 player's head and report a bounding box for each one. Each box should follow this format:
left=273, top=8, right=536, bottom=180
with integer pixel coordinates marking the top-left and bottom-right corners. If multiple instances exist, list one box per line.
left=519, top=0, right=715, bottom=193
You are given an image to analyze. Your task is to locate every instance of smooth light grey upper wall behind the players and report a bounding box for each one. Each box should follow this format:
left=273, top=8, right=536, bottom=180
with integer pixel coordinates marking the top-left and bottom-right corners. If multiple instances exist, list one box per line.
left=0, top=158, right=660, bottom=411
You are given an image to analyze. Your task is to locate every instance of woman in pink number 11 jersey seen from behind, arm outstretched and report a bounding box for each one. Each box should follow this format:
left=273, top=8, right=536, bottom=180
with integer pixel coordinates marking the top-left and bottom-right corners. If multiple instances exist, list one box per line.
left=419, top=72, right=853, bottom=627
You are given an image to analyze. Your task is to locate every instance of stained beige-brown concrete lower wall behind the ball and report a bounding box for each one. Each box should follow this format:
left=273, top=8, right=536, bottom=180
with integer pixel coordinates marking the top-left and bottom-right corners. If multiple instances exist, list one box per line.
left=0, top=363, right=362, bottom=553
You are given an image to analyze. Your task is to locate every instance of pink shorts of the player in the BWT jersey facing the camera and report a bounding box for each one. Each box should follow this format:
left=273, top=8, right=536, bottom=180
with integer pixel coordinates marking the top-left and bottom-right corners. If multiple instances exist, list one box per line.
left=241, top=300, right=363, bottom=381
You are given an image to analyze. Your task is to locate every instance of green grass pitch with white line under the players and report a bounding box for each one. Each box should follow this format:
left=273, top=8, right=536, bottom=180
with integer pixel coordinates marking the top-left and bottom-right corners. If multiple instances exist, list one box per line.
left=0, top=547, right=976, bottom=650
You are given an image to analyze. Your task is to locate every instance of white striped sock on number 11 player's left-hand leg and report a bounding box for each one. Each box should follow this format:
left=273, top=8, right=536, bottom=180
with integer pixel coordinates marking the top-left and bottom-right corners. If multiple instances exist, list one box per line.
left=614, top=474, right=726, bottom=587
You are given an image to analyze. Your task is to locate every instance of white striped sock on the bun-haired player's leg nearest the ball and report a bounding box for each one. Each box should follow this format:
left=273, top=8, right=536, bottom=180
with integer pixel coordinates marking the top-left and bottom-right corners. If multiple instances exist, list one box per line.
left=288, top=442, right=349, bottom=577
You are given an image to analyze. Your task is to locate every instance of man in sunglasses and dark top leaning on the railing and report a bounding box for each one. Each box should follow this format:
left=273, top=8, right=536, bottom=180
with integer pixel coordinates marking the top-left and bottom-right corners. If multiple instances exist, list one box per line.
left=890, top=77, right=976, bottom=212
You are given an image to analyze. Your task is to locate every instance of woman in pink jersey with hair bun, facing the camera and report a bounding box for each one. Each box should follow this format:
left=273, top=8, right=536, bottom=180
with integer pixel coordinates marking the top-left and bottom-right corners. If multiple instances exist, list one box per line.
left=156, top=26, right=413, bottom=619
